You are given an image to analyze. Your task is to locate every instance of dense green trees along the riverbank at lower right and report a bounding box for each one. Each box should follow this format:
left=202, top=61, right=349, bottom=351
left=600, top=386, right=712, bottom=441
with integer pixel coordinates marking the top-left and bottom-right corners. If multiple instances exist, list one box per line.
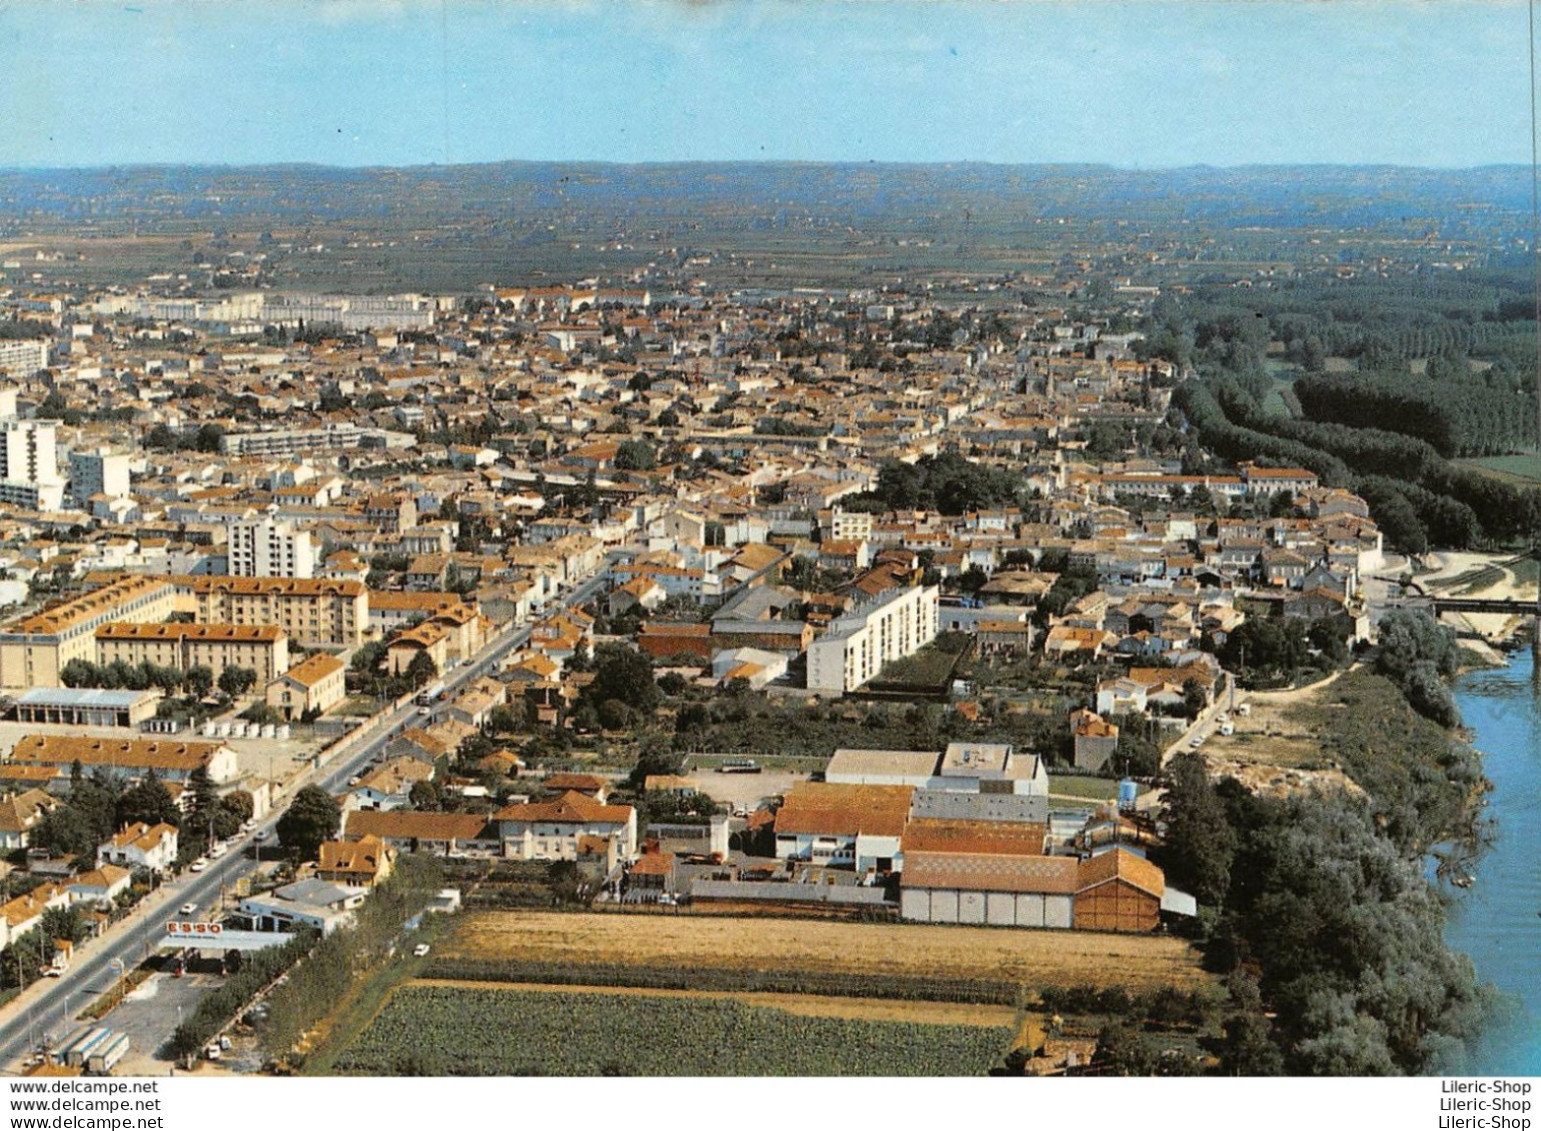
left=1162, top=613, right=1501, bottom=1076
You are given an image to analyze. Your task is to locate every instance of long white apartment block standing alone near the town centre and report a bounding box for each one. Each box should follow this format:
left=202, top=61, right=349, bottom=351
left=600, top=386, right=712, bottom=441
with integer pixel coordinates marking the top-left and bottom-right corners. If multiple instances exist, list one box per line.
left=807, top=586, right=940, bottom=695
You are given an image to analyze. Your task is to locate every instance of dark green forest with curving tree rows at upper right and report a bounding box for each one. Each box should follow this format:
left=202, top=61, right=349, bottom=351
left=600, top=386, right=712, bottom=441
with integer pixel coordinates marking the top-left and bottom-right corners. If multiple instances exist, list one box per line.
left=1143, top=277, right=1541, bottom=553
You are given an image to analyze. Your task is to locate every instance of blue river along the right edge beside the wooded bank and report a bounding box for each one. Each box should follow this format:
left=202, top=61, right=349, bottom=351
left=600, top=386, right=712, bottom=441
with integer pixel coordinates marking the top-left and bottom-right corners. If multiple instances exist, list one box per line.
left=1445, top=649, right=1541, bottom=1076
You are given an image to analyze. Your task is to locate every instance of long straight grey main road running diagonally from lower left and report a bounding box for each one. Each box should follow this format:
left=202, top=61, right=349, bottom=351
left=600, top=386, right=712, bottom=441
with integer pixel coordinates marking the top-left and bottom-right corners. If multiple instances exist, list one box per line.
left=0, top=567, right=618, bottom=1066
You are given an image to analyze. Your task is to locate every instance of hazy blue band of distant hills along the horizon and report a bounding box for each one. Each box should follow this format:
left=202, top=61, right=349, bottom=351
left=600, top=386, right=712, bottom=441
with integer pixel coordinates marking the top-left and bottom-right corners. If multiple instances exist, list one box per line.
left=0, top=162, right=1530, bottom=227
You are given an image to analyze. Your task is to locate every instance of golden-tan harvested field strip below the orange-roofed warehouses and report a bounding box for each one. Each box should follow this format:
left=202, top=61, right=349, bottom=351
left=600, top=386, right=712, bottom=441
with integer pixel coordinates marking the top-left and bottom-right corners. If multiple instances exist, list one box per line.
left=439, top=912, right=1210, bottom=995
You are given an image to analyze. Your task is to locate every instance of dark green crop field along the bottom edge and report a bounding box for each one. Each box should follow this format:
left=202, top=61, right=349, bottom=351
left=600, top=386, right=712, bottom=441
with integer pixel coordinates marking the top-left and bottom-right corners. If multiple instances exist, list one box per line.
left=336, top=985, right=1012, bottom=1076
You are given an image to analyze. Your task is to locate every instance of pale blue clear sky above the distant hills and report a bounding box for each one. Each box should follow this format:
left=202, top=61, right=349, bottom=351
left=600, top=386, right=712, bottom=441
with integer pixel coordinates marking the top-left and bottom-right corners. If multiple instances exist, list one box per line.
left=0, top=0, right=1530, bottom=168
